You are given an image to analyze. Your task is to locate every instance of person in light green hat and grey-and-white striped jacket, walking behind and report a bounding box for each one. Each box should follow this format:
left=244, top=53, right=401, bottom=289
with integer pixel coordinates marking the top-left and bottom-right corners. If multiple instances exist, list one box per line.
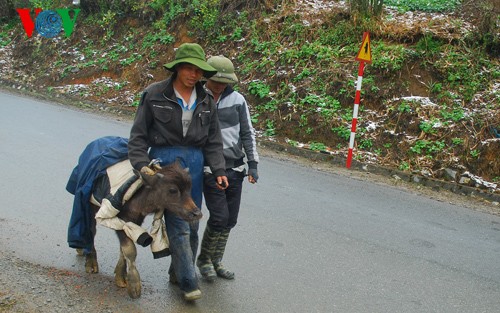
left=196, top=56, right=259, bottom=281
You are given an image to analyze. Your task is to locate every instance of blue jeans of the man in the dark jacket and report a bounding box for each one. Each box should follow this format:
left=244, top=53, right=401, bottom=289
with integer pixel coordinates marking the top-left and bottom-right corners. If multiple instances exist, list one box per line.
left=149, top=147, right=204, bottom=292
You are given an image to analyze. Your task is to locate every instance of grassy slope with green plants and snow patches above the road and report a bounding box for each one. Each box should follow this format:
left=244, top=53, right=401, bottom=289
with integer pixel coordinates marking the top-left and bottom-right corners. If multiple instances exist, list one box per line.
left=0, top=1, right=500, bottom=188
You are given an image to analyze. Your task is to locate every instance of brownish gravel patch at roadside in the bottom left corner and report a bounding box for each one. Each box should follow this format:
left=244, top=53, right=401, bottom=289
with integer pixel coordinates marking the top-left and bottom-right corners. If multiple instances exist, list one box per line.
left=0, top=247, right=140, bottom=313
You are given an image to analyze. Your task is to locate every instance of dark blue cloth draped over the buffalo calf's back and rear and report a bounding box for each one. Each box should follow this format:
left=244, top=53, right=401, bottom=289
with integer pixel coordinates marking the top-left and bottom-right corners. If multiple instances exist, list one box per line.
left=66, top=136, right=128, bottom=251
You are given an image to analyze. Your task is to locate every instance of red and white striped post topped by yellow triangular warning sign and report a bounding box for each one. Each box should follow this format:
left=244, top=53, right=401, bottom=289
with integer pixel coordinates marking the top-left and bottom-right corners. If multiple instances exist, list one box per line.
left=346, top=32, right=372, bottom=168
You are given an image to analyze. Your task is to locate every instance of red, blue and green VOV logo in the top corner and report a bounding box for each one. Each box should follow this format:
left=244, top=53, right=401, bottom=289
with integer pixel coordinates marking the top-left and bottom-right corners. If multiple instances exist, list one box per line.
left=16, top=8, right=80, bottom=38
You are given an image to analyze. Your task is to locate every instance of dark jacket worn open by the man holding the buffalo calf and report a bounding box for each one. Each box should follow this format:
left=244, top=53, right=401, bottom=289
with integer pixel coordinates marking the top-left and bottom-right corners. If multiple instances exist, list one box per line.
left=128, top=74, right=226, bottom=176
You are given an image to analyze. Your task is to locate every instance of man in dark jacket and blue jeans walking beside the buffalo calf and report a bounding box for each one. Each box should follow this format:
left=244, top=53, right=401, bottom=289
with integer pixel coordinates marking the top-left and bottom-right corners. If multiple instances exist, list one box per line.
left=128, top=43, right=228, bottom=301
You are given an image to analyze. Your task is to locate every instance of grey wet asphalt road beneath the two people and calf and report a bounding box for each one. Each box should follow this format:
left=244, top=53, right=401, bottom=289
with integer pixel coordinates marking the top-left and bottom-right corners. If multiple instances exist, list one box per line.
left=0, top=89, right=500, bottom=313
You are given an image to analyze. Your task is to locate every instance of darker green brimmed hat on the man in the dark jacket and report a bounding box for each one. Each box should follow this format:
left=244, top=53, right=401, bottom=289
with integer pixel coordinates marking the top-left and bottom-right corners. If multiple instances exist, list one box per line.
left=163, top=43, right=217, bottom=78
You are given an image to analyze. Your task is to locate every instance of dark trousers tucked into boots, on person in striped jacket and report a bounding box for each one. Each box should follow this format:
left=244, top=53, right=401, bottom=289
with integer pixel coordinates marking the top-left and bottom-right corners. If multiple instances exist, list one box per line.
left=203, top=169, right=245, bottom=231
